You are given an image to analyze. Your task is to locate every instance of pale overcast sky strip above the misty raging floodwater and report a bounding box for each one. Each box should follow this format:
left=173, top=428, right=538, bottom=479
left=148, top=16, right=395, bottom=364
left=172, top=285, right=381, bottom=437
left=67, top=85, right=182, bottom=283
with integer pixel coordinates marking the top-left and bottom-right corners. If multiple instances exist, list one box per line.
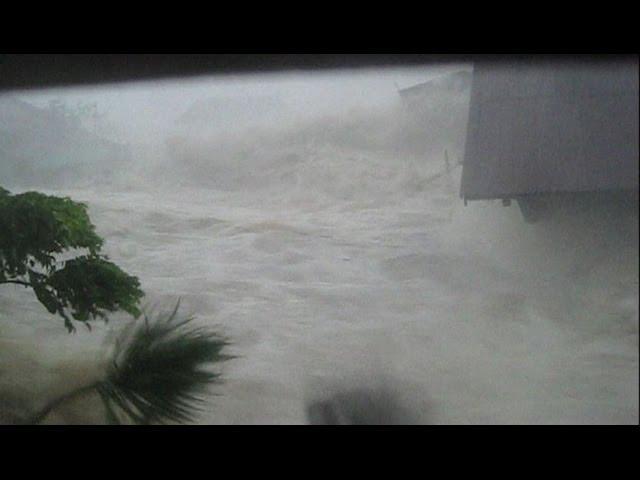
left=17, top=65, right=467, bottom=141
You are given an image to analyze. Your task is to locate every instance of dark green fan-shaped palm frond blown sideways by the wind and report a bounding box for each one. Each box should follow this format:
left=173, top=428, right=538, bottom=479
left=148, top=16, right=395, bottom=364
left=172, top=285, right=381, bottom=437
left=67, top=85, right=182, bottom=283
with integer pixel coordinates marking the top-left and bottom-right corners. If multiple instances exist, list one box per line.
left=96, top=302, right=233, bottom=424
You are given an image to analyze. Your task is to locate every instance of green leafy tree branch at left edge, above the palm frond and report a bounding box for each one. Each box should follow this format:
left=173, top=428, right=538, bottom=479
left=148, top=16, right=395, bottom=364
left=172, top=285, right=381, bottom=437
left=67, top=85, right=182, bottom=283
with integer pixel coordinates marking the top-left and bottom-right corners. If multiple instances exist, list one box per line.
left=0, top=188, right=144, bottom=331
